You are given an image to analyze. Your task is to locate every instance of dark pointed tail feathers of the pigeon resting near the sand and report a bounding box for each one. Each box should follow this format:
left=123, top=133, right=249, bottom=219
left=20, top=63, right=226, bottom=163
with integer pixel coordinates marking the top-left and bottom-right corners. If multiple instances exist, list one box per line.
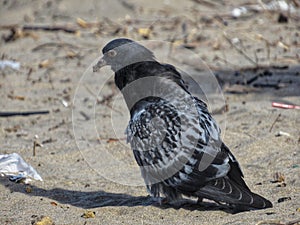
left=196, top=177, right=272, bottom=211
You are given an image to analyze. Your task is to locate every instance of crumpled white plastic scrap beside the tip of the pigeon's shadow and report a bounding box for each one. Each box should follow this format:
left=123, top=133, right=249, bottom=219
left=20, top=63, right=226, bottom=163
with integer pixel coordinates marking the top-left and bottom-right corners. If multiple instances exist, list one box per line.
left=0, top=153, right=43, bottom=183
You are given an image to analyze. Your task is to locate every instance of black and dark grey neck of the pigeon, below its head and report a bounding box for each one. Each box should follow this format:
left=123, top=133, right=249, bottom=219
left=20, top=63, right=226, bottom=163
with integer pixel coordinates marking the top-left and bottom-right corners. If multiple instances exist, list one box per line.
left=115, top=61, right=190, bottom=114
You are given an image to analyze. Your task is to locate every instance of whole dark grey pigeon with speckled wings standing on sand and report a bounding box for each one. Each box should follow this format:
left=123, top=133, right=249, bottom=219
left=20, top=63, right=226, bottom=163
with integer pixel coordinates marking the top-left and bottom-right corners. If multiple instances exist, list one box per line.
left=93, top=38, right=272, bottom=211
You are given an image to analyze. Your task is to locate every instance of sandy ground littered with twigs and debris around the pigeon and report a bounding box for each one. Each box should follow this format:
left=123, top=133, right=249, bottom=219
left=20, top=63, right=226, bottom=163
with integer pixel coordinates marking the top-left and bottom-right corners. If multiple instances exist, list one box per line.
left=0, top=0, right=300, bottom=224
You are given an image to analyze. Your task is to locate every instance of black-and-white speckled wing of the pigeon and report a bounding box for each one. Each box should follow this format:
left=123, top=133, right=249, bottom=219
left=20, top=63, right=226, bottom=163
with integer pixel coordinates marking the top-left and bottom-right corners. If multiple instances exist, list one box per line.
left=127, top=95, right=230, bottom=188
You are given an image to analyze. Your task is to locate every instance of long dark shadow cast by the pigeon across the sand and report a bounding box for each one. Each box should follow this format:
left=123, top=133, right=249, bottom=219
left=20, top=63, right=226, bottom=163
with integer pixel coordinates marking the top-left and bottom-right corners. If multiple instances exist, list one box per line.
left=0, top=177, right=236, bottom=214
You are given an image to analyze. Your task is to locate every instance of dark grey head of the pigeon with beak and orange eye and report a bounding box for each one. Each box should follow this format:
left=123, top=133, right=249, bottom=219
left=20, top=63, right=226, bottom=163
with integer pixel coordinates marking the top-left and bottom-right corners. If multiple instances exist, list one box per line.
left=93, top=38, right=154, bottom=72
